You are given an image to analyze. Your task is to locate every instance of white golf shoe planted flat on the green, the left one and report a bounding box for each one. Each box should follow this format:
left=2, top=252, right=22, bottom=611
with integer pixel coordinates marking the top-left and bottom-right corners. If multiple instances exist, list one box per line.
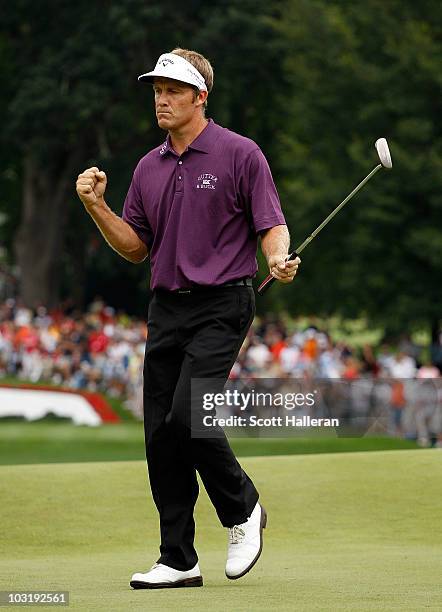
left=130, top=563, right=203, bottom=589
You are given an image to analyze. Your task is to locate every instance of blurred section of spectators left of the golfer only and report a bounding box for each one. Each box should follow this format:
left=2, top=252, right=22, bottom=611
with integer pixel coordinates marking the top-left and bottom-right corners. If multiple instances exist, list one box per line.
left=0, top=298, right=147, bottom=407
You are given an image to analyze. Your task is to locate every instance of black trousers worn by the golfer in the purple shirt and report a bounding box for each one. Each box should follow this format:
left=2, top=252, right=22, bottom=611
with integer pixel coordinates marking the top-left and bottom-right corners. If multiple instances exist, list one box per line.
left=144, top=286, right=258, bottom=570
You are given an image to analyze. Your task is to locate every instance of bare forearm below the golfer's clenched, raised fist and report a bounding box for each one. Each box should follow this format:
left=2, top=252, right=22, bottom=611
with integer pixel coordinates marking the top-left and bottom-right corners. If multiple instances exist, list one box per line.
left=87, top=199, right=148, bottom=263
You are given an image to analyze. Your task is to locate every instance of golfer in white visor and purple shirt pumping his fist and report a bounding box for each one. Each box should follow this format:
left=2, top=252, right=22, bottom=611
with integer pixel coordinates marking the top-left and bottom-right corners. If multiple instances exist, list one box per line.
left=77, top=49, right=300, bottom=588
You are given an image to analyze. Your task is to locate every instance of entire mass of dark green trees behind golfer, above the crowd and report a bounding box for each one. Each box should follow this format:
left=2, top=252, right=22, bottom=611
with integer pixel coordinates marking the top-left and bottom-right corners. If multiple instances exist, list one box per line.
left=0, top=0, right=442, bottom=329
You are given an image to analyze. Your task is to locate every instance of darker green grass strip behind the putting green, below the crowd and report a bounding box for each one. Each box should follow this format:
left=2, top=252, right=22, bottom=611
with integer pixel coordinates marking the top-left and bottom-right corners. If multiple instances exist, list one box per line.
left=0, top=419, right=416, bottom=465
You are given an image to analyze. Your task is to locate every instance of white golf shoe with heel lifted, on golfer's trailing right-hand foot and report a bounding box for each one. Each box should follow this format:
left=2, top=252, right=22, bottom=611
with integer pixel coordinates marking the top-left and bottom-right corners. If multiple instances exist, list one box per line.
left=226, top=503, right=267, bottom=580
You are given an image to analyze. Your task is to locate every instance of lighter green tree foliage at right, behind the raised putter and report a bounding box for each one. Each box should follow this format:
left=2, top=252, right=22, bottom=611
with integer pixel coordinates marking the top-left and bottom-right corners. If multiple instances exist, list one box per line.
left=275, top=0, right=442, bottom=329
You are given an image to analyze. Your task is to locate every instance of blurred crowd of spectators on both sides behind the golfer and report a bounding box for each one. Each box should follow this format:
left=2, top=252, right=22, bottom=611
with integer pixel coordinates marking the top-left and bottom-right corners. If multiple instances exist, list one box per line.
left=0, top=298, right=441, bottom=442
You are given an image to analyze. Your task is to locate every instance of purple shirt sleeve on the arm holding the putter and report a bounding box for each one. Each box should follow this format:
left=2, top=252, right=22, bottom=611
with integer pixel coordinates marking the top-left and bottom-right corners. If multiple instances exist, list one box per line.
left=244, top=148, right=286, bottom=233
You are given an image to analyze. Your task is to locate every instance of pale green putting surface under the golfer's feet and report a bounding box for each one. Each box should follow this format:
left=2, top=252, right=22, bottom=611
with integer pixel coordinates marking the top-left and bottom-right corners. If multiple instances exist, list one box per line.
left=0, top=450, right=442, bottom=612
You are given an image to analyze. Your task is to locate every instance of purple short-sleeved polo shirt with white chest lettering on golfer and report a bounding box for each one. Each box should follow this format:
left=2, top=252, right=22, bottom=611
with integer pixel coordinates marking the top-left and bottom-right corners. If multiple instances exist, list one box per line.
left=123, top=119, right=285, bottom=290
